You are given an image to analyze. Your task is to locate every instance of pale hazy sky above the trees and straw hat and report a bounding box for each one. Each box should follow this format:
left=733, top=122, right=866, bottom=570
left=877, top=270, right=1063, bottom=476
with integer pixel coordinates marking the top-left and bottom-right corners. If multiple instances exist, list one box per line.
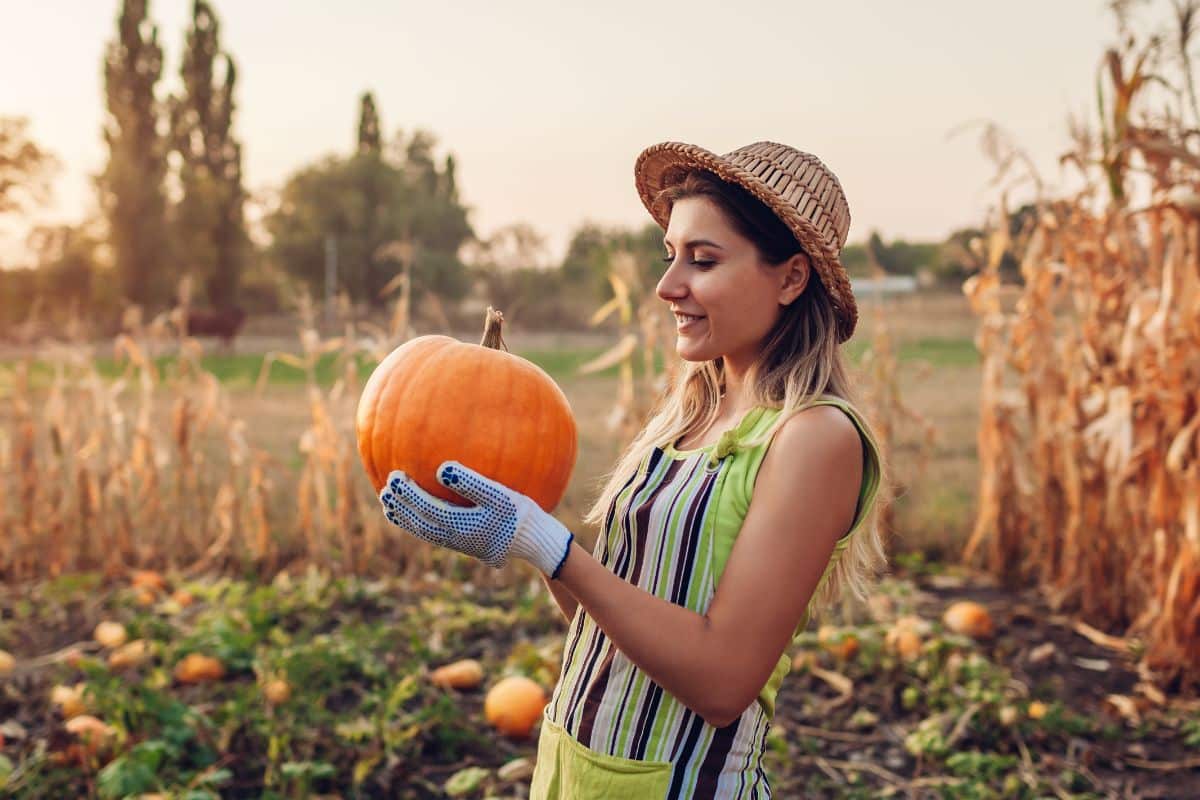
left=0, top=0, right=1115, bottom=265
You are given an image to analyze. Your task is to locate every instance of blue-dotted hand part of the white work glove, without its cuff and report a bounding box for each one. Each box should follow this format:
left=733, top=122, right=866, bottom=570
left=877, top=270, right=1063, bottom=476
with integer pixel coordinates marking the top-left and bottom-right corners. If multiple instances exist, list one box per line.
left=379, top=462, right=517, bottom=567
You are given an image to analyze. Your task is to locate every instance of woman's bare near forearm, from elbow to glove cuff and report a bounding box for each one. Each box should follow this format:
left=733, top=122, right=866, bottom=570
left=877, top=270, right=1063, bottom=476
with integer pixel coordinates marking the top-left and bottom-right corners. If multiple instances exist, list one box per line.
left=547, top=542, right=740, bottom=724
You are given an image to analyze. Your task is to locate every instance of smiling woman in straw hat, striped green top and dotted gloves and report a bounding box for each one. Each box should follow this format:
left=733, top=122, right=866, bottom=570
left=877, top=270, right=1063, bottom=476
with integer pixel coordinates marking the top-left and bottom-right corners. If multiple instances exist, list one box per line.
left=380, top=143, right=884, bottom=800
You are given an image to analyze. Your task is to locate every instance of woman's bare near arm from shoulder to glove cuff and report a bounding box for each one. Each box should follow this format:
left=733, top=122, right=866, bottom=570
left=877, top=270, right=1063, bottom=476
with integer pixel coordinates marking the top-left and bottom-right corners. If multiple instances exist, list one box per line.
left=548, top=407, right=863, bottom=727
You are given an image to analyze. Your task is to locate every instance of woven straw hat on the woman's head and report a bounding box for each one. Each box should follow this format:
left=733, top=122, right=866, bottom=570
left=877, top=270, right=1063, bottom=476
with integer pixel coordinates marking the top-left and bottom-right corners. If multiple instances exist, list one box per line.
left=634, top=142, right=858, bottom=342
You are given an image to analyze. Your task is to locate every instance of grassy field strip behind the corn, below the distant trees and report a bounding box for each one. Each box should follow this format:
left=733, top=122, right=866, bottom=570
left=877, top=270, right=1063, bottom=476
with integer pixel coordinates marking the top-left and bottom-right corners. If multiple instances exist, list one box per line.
left=0, top=293, right=979, bottom=559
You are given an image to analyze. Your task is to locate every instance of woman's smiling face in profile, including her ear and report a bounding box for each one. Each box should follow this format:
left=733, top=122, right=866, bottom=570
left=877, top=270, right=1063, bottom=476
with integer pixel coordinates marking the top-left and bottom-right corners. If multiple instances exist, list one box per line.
left=656, top=197, right=809, bottom=369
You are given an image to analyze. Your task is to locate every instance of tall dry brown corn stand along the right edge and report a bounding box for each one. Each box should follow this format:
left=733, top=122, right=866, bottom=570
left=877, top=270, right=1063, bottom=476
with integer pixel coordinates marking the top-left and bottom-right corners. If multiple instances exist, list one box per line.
left=965, top=18, right=1200, bottom=680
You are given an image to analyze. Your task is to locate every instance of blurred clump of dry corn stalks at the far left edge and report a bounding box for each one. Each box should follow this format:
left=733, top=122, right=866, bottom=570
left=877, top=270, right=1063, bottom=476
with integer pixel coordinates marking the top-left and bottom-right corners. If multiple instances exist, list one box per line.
left=0, top=291, right=264, bottom=578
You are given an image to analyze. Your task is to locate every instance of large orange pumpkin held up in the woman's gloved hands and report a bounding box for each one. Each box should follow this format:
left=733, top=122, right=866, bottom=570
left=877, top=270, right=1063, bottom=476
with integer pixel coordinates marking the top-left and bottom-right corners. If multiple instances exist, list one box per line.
left=355, top=308, right=577, bottom=511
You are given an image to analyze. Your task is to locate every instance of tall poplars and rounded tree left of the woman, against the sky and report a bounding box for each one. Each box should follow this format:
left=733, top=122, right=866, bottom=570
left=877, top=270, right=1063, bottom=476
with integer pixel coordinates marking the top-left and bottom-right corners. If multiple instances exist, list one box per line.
left=0, top=0, right=474, bottom=331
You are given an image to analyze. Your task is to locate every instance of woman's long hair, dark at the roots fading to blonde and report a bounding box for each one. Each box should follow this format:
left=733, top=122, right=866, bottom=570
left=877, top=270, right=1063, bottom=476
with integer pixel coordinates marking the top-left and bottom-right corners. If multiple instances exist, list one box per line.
left=584, top=170, right=887, bottom=615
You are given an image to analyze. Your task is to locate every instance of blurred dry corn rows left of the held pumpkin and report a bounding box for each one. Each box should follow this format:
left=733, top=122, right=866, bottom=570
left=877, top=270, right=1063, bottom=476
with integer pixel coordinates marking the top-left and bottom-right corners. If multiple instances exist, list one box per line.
left=0, top=287, right=518, bottom=585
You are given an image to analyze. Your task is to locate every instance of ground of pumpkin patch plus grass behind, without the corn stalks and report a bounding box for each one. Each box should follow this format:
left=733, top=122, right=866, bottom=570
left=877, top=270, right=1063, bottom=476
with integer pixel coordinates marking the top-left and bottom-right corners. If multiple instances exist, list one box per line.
left=0, top=294, right=1200, bottom=800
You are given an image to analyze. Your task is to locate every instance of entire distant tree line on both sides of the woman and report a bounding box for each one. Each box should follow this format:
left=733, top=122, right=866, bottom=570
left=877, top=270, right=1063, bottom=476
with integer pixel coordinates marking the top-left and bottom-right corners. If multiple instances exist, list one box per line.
left=0, top=0, right=1003, bottom=338
